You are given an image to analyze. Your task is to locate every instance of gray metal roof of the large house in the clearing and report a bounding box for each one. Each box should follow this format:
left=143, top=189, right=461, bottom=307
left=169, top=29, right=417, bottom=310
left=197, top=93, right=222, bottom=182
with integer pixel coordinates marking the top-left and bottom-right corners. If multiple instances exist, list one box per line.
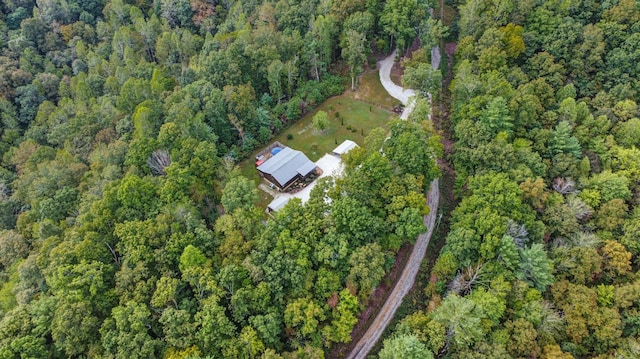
left=258, top=147, right=316, bottom=186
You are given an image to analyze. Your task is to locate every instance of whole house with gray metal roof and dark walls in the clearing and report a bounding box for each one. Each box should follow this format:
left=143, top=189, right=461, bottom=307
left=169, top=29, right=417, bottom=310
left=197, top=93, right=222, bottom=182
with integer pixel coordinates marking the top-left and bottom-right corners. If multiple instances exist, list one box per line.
left=257, top=146, right=316, bottom=191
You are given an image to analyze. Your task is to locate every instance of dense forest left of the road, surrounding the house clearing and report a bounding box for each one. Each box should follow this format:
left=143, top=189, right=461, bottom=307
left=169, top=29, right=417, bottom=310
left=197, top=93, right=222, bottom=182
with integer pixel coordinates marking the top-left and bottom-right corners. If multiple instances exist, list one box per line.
left=0, top=0, right=442, bottom=359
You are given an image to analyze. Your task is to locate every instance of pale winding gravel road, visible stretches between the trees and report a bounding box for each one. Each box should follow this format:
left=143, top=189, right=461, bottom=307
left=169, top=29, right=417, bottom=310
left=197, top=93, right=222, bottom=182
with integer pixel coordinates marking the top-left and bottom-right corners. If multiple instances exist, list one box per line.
left=347, top=51, right=440, bottom=359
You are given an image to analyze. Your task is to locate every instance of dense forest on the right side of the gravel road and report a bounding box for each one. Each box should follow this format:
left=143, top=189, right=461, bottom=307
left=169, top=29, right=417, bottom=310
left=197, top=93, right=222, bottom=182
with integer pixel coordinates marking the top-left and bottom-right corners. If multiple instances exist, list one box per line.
left=380, top=0, right=640, bottom=359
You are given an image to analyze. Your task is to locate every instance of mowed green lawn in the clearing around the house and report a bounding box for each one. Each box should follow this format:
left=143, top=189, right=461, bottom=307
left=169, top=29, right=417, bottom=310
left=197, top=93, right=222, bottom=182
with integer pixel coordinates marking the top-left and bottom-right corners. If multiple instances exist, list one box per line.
left=238, top=71, right=400, bottom=208
